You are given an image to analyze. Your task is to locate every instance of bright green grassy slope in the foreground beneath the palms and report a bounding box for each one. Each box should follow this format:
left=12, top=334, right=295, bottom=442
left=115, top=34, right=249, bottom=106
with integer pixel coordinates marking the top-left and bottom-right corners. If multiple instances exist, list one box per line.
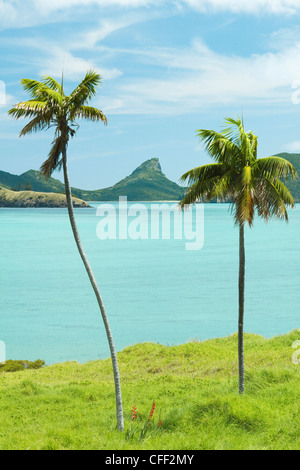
left=0, top=330, right=300, bottom=450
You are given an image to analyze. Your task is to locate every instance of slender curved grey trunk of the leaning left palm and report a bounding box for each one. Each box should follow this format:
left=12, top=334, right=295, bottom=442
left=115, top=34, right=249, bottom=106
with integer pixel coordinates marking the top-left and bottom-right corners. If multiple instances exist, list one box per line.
left=62, top=149, right=124, bottom=431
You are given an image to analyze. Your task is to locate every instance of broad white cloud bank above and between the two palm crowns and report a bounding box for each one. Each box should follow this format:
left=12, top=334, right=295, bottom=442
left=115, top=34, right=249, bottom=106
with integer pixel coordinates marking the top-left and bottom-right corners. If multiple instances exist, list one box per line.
left=98, top=40, right=300, bottom=114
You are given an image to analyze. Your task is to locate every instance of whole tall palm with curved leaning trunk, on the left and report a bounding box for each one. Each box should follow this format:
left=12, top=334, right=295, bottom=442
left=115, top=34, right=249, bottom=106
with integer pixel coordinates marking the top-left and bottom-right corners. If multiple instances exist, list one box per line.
left=9, top=70, right=124, bottom=431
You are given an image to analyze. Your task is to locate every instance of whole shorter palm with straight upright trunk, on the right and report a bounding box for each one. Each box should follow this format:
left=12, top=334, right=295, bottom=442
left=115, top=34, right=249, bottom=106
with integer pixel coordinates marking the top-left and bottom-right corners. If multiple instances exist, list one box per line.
left=180, top=118, right=297, bottom=393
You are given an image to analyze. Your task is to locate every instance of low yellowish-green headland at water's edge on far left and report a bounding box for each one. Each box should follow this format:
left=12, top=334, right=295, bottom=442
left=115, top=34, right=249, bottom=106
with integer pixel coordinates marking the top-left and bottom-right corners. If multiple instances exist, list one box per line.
left=0, top=187, right=89, bottom=208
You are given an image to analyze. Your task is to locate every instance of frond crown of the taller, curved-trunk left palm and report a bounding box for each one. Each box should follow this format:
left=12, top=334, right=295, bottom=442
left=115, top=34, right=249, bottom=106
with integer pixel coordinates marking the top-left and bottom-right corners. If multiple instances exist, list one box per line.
left=9, top=70, right=107, bottom=178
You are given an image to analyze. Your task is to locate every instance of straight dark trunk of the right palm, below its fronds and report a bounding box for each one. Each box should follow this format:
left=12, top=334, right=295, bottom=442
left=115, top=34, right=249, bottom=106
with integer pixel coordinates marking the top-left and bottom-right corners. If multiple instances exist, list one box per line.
left=238, top=223, right=245, bottom=394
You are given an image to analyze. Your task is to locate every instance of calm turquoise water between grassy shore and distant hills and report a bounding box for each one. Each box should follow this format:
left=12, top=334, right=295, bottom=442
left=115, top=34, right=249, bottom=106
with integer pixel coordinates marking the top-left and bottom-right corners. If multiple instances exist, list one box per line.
left=0, top=203, right=300, bottom=364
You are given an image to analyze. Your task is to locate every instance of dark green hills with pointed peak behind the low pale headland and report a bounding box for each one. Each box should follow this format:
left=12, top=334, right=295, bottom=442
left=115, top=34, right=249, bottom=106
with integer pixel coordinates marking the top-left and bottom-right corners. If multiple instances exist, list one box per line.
left=0, top=158, right=184, bottom=201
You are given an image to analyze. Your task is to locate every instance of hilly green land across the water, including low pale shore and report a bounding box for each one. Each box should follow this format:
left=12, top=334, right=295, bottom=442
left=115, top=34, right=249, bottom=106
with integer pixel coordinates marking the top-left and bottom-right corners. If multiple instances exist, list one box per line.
left=0, top=153, right=300, bottom=207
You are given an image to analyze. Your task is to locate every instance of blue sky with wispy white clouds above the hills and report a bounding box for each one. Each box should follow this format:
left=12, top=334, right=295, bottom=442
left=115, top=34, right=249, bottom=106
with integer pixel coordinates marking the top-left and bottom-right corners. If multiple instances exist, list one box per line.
left=0, top=0, right=300, bottom=189
